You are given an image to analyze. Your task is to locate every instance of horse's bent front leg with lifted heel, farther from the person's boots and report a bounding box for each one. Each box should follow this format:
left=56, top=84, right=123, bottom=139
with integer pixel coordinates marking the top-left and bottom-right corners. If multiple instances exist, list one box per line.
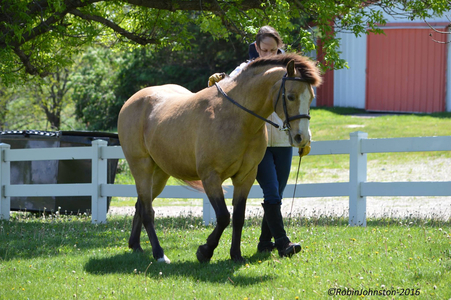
left=196, top=176, right=230, bottom=262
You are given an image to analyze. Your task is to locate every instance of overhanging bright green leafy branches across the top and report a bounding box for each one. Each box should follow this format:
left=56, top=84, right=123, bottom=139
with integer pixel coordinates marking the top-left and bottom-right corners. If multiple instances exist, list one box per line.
left=0, top=0, right=451, bottom=84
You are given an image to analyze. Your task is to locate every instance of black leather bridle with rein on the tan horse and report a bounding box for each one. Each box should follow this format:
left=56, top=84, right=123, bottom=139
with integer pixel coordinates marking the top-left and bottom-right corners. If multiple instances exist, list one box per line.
left=215, top=73, right=310, bottom=130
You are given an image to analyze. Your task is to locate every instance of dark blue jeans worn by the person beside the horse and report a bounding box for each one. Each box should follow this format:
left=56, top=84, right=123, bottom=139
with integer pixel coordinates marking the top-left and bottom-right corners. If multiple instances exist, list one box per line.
left=257, top=147, right=293, bottom=204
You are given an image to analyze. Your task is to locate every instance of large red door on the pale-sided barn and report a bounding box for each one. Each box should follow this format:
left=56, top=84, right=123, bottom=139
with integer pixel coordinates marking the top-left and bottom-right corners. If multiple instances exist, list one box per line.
left=366, top=23, right=446, bottom=113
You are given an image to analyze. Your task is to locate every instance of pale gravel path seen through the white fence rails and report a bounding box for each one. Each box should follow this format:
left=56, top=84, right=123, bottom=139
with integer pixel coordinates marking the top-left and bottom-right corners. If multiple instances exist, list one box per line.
left=109, top=158, right=451, bottom=220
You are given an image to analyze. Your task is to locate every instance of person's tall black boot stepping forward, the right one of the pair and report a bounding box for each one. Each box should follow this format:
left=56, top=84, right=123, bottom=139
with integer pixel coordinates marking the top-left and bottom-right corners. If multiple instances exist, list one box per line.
left=262, top=203, right=301, bottom=257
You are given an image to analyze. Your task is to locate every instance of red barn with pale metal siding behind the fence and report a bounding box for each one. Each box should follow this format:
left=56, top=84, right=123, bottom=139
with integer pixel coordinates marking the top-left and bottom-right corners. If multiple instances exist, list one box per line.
left=316, top=12, right=451, bottom=113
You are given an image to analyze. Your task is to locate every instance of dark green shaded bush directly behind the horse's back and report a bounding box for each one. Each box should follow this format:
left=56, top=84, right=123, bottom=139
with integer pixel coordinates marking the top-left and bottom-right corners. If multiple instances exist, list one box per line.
left=94, top=30, right=248, bottom=130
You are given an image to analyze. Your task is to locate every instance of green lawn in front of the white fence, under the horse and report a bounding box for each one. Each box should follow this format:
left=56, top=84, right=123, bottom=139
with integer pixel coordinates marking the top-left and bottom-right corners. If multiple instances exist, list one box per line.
left=0, top=213, right=451, bottom=299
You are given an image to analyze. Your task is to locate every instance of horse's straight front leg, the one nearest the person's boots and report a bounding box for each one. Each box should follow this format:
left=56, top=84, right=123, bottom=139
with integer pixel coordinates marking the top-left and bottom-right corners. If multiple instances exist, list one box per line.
left=230, top=171, right=256, bottom=262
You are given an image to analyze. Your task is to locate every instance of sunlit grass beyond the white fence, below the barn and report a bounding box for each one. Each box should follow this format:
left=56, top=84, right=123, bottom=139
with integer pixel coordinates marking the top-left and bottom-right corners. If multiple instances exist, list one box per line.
left=111, top=107, right=451, bottom=206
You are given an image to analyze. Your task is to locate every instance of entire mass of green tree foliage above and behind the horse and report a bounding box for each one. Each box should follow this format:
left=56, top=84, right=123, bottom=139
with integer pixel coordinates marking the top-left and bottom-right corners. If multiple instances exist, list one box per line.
left=0, top=0, right=451, bottom=130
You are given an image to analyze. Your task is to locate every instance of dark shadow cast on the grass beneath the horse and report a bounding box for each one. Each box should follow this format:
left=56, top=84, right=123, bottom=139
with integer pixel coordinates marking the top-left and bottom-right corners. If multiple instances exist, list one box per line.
left=84, top=251, right=275, bottom=286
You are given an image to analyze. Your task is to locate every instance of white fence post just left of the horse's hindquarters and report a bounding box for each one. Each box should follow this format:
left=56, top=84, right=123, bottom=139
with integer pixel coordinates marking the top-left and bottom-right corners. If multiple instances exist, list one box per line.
left=91, top=140, right=108, bottom=224
